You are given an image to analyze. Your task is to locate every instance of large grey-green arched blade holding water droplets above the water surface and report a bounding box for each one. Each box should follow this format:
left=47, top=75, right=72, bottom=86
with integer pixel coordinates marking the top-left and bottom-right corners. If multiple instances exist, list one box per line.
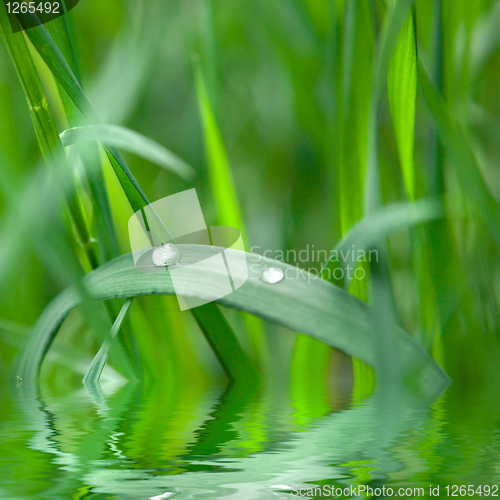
left=18, top=245, right=447, bottom=389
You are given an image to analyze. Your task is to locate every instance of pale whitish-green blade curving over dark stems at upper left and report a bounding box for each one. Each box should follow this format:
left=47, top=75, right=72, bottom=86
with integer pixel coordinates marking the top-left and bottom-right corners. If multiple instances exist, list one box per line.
left=60, top=125, right=195, bottom=181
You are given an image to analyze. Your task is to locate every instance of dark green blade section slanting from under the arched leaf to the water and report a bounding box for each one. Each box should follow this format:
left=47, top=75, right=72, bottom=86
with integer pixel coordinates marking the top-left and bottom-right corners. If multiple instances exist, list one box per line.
left=191, top=303, right=258, bottom=383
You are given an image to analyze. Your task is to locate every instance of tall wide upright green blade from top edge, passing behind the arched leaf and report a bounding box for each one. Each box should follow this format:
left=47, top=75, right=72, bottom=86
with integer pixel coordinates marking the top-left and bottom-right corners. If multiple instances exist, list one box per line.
left=312, top=0, right=374, bottom=402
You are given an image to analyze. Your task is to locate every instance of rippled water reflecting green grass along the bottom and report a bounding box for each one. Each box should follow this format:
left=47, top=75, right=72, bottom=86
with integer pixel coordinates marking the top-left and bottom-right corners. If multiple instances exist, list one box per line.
left=0, top=376, right=500, bottom=500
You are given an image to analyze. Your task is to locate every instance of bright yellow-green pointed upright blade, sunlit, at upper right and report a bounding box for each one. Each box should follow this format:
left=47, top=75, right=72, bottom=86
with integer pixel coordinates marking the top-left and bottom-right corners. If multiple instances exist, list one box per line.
left=388, top=14, right=417, bottom=200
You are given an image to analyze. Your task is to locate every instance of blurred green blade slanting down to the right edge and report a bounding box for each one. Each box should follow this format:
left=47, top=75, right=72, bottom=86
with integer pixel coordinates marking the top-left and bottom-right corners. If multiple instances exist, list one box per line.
left=418, top=62, right=500, bottom=240
